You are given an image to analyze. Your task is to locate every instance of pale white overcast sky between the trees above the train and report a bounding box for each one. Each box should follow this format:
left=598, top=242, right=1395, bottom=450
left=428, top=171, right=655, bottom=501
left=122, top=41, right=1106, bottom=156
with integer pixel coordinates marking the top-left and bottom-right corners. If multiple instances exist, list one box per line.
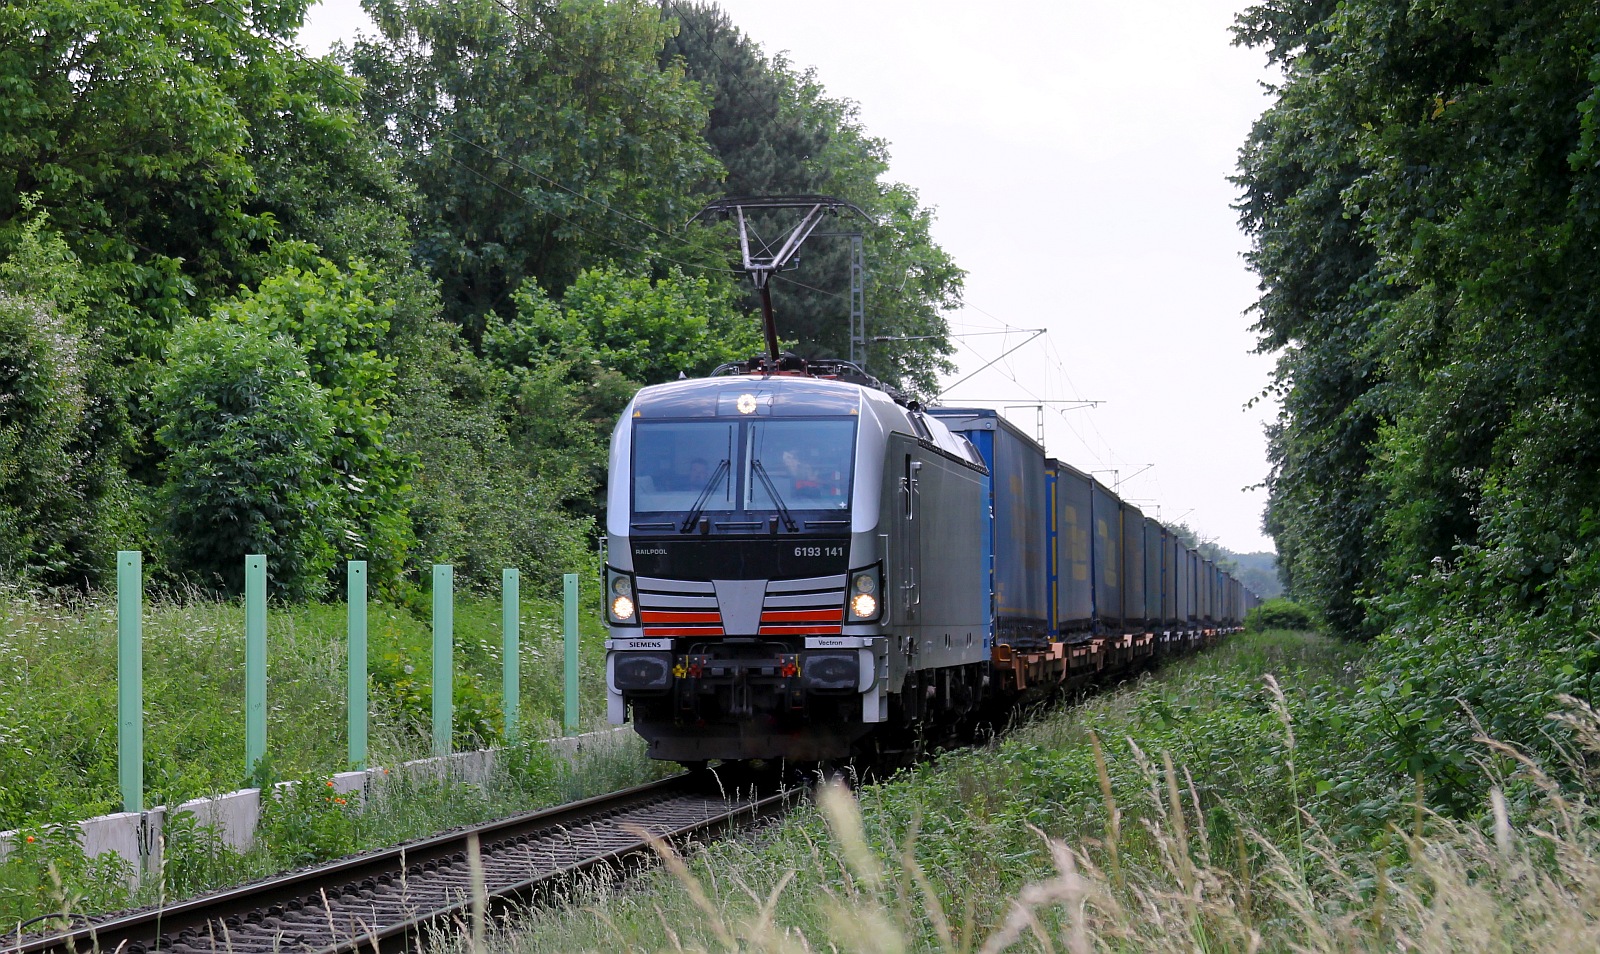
left=301, top=0, right=1277, bottom=552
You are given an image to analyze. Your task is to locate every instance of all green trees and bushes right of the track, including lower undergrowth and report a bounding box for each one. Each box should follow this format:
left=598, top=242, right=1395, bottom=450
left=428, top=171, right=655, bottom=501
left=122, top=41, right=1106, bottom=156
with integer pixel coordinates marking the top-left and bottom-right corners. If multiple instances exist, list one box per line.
left=1240, top=0, right=1600, bottom=815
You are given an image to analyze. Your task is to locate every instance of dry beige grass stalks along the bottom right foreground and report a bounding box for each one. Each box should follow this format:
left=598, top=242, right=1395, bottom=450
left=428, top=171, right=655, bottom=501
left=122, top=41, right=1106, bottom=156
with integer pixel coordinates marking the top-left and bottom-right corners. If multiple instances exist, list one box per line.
left=489, top=680, right=1600, bottom=954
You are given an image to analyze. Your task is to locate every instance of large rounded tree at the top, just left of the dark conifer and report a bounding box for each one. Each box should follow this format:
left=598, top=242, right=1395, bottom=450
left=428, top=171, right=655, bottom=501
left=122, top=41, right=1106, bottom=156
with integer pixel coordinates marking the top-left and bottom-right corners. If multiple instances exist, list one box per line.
left=347, top=0, right=732, bottom=343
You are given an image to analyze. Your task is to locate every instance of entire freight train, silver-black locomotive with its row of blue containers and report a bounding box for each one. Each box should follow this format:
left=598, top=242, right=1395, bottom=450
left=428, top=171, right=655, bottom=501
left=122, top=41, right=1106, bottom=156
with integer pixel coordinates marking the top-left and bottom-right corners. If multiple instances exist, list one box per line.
left=603, top=357, right=1259, bottom=765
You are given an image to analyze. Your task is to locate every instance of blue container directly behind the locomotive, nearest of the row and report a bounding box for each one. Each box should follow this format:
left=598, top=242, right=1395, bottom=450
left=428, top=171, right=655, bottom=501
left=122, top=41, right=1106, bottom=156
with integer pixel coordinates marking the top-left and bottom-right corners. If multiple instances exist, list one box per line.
left=928, top=408, right=1050, bottom=648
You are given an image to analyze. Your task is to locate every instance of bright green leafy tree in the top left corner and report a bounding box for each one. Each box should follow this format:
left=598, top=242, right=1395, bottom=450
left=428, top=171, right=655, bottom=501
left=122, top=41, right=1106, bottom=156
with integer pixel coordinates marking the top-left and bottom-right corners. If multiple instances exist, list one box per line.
left=0, top=0, right=397, bottom=340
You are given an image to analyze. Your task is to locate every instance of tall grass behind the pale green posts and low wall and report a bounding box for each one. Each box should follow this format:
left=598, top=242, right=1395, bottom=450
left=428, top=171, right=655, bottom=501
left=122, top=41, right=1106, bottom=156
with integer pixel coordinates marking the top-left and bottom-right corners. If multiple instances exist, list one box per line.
left=0, top=576, right=605, bottom=831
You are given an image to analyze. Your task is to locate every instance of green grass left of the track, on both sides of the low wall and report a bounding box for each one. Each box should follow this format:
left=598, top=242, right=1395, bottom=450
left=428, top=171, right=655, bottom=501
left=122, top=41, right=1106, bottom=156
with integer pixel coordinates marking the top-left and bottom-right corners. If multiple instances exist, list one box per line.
left=0, top=587, right=656, bottom=924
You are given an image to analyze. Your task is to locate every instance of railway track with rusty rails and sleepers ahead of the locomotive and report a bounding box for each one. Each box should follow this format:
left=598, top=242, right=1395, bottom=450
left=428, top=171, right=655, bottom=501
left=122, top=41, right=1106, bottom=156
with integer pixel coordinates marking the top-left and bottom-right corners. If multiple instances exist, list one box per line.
left=0, top=775, right=797, bottom=954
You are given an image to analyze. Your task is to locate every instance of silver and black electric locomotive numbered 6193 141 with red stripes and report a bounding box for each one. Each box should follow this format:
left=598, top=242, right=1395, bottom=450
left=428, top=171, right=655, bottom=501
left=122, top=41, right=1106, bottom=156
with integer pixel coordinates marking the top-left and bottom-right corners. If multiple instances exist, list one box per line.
left=605, top=357, right=992, bottom=765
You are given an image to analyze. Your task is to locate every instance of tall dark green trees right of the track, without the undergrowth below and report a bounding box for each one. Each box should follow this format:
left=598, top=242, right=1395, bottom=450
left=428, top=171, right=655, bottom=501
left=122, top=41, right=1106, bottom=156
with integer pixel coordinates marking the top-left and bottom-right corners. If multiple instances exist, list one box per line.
left=1240, top=0, right=1600, bottom=635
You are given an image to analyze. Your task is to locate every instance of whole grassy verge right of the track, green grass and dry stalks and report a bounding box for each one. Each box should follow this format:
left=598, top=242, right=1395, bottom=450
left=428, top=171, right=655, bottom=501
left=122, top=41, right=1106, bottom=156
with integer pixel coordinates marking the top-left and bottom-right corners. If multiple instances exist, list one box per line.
left=493, top=632, right=1600, bottom=951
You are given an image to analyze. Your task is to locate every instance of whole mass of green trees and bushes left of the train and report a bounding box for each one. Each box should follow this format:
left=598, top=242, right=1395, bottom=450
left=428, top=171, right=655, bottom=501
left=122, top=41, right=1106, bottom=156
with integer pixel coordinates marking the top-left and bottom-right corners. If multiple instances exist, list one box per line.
left=0, top=0, right=960, bottom=585
